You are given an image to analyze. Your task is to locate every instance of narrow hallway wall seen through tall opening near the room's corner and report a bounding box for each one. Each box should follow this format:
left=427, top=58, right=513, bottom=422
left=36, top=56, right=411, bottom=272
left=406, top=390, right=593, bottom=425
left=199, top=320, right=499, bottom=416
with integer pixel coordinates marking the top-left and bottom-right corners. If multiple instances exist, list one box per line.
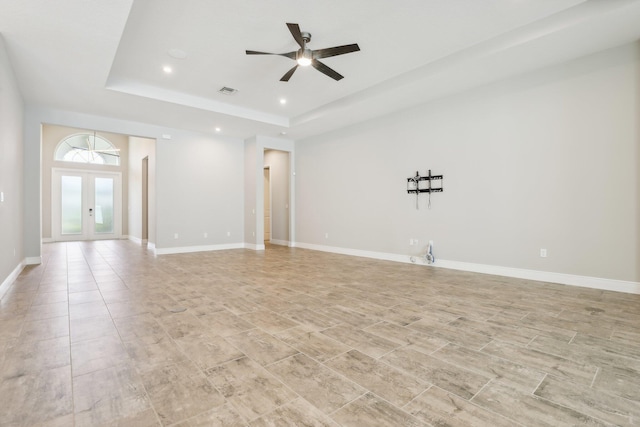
left=264, top=150, right=290, bottom=245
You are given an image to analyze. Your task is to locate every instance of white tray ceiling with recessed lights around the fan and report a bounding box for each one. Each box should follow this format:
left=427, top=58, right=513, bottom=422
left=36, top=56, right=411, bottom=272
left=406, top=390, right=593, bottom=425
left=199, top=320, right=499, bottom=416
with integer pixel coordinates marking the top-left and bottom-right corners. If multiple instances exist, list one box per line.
left=0, top=0, right=640, bottom=139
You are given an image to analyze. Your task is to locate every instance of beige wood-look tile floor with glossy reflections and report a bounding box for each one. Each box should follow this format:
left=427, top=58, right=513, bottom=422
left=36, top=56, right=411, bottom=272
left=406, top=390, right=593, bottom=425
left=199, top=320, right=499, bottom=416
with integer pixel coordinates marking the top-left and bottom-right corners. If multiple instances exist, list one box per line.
left=0, top=241, right=640, bottom=427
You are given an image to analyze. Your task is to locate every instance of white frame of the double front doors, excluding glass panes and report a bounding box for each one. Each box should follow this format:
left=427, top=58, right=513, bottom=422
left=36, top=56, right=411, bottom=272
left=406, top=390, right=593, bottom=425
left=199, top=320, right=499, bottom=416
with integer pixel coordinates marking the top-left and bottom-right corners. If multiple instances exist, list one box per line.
left=51, top=168, right=122, bottom=242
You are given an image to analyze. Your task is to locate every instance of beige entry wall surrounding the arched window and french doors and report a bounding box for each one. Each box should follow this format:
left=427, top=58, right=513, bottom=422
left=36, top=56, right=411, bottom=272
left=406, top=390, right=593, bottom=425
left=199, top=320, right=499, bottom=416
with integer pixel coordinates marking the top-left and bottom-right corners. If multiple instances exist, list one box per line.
left=42, top=124, right=129, bottom=241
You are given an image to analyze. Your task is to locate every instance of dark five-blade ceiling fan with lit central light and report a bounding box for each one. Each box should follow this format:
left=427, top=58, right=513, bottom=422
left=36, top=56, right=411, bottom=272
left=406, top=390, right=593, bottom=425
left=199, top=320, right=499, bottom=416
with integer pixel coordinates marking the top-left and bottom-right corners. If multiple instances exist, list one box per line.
left=246, top=24, right=360, bottom=82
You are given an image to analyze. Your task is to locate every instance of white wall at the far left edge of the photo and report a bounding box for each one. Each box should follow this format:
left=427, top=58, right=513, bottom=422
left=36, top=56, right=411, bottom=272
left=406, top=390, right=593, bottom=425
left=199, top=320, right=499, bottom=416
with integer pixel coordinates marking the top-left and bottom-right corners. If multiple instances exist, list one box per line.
left=0, top=35, right=24, bottom=297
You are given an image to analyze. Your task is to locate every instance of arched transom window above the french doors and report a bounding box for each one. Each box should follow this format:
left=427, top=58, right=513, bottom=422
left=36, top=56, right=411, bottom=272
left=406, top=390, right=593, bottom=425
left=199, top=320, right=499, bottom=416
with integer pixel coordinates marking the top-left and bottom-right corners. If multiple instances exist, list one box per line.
left=54, top=133, right=120, bottom=166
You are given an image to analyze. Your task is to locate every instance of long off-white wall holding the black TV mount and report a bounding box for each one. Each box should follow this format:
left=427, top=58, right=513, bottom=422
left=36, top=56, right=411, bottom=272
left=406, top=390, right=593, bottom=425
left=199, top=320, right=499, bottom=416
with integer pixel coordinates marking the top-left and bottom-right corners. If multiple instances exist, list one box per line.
left=296, top=44, right=640, bottom=282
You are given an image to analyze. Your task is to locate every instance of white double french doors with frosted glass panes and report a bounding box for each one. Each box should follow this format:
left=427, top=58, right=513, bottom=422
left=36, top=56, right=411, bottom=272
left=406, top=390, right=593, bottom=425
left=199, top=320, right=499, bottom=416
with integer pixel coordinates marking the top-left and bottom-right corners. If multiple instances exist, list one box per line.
left=51, top=168, right=122, bottom=241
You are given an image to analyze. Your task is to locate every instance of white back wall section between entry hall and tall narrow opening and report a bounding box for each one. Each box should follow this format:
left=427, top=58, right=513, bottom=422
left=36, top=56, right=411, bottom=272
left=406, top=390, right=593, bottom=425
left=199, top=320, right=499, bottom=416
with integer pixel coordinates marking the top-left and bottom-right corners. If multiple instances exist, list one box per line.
left=156, top=135, right=244, bottom=248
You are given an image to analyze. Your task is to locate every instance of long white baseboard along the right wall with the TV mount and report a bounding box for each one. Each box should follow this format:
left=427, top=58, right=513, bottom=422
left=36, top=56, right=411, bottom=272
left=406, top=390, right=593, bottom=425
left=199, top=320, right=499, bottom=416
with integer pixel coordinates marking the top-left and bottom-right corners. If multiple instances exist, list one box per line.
left=292, top=242, right=640, bottom=294
